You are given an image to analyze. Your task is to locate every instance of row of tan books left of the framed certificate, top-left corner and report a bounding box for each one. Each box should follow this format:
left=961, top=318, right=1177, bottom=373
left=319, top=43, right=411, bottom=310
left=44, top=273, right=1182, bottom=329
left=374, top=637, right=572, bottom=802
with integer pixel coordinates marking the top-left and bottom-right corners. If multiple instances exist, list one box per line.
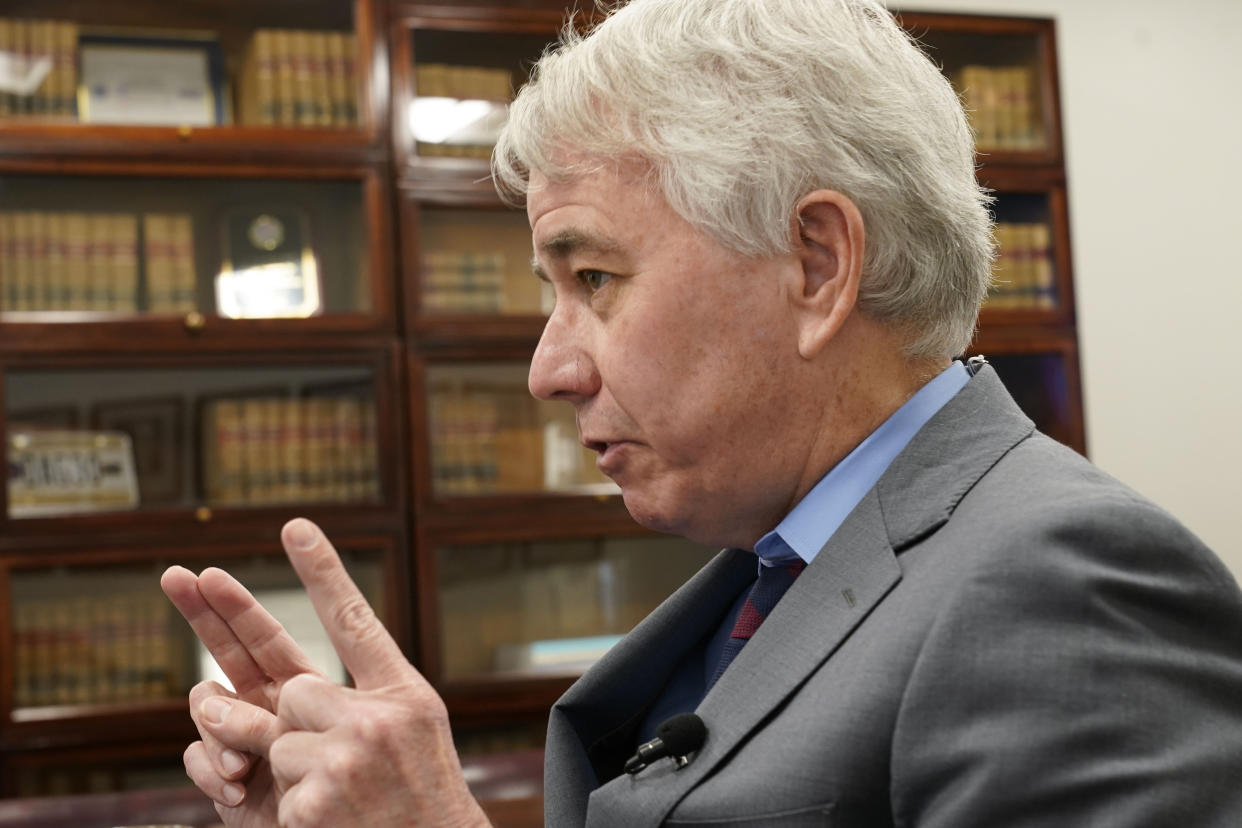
left=0, top=17, right=78, bottom=120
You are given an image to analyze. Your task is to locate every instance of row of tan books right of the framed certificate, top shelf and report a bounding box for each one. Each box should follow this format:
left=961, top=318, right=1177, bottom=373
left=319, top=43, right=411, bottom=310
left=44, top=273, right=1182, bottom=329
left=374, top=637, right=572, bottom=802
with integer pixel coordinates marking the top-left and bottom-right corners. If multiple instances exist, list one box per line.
left=237, top=29, right=358, bottom=127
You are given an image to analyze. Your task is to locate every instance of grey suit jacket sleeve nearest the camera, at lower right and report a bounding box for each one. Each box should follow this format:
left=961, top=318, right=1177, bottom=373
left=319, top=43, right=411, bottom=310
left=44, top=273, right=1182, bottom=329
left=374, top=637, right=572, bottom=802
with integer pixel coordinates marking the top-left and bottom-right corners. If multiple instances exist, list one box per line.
left=892, top=493, right=1242, bottom=828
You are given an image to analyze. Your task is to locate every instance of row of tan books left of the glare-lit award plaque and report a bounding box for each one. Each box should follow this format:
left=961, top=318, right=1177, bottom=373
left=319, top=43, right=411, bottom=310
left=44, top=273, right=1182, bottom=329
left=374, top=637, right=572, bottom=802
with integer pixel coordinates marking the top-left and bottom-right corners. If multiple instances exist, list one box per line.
left=0, top=210, right=196, bottom=313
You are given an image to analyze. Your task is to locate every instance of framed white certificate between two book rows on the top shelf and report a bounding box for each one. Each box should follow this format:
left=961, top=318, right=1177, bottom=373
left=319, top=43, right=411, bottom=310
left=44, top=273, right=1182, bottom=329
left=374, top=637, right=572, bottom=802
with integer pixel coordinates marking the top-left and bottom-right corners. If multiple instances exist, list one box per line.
left=78, top=34, right=229, bottom=127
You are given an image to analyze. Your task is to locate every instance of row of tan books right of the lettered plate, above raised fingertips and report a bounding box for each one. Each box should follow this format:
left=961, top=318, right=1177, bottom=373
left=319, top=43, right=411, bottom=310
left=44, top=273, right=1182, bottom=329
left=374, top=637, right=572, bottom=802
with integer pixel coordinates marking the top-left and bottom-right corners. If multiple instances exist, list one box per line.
left=202, top=396, right=379, bottom=505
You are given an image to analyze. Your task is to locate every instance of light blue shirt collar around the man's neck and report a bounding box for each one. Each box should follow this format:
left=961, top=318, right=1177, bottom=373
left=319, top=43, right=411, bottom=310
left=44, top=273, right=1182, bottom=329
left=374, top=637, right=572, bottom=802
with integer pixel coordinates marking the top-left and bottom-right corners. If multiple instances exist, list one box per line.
left=755, top=361, right=970, bottom=566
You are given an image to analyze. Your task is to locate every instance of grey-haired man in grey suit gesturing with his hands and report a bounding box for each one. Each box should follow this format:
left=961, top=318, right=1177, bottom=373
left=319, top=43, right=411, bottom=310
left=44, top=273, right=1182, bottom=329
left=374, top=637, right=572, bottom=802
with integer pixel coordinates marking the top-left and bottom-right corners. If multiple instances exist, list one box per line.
left=164, top=0, right=1242, bottom=828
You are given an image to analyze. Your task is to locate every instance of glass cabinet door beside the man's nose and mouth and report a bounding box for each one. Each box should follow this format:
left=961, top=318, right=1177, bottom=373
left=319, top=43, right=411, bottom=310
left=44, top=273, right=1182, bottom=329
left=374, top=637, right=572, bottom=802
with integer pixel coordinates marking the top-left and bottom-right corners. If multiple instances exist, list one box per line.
left=427, top=362, right=620, bottom=497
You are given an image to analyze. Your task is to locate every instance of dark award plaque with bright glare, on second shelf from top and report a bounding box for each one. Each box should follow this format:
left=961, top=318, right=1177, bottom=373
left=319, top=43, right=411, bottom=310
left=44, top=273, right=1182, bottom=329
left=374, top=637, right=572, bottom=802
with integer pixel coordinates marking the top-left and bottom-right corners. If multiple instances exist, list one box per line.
left=216, top=207, right=323, bottom=319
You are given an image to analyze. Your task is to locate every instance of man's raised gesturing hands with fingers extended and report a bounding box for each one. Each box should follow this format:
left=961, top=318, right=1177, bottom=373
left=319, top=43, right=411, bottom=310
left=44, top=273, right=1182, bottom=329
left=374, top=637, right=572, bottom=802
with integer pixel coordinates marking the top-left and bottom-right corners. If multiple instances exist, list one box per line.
left=164, top=519, right=488, bottom=828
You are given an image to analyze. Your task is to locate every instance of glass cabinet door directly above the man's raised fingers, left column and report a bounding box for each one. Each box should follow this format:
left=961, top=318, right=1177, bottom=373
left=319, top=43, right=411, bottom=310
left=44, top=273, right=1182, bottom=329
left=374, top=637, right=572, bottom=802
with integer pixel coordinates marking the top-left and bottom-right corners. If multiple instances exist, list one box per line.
left=4, top=364, right=383, bottom=519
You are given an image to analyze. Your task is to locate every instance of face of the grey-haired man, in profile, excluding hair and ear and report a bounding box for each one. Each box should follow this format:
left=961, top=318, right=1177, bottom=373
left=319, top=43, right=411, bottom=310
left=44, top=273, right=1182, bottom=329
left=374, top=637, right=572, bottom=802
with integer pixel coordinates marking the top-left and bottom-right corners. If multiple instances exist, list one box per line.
left=527, top=168, right=807, bottom=546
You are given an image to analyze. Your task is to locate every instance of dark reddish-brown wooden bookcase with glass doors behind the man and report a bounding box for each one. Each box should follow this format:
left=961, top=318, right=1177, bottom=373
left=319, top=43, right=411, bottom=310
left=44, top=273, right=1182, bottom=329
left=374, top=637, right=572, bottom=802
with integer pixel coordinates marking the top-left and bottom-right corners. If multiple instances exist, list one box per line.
left=0, top=0, right=1084, bottom=819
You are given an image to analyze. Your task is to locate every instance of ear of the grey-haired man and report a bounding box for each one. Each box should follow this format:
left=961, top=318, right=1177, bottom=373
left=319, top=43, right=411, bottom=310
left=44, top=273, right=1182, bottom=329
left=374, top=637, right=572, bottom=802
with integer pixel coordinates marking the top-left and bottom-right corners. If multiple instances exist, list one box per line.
left=790, top=190, right=866, bottom=359
